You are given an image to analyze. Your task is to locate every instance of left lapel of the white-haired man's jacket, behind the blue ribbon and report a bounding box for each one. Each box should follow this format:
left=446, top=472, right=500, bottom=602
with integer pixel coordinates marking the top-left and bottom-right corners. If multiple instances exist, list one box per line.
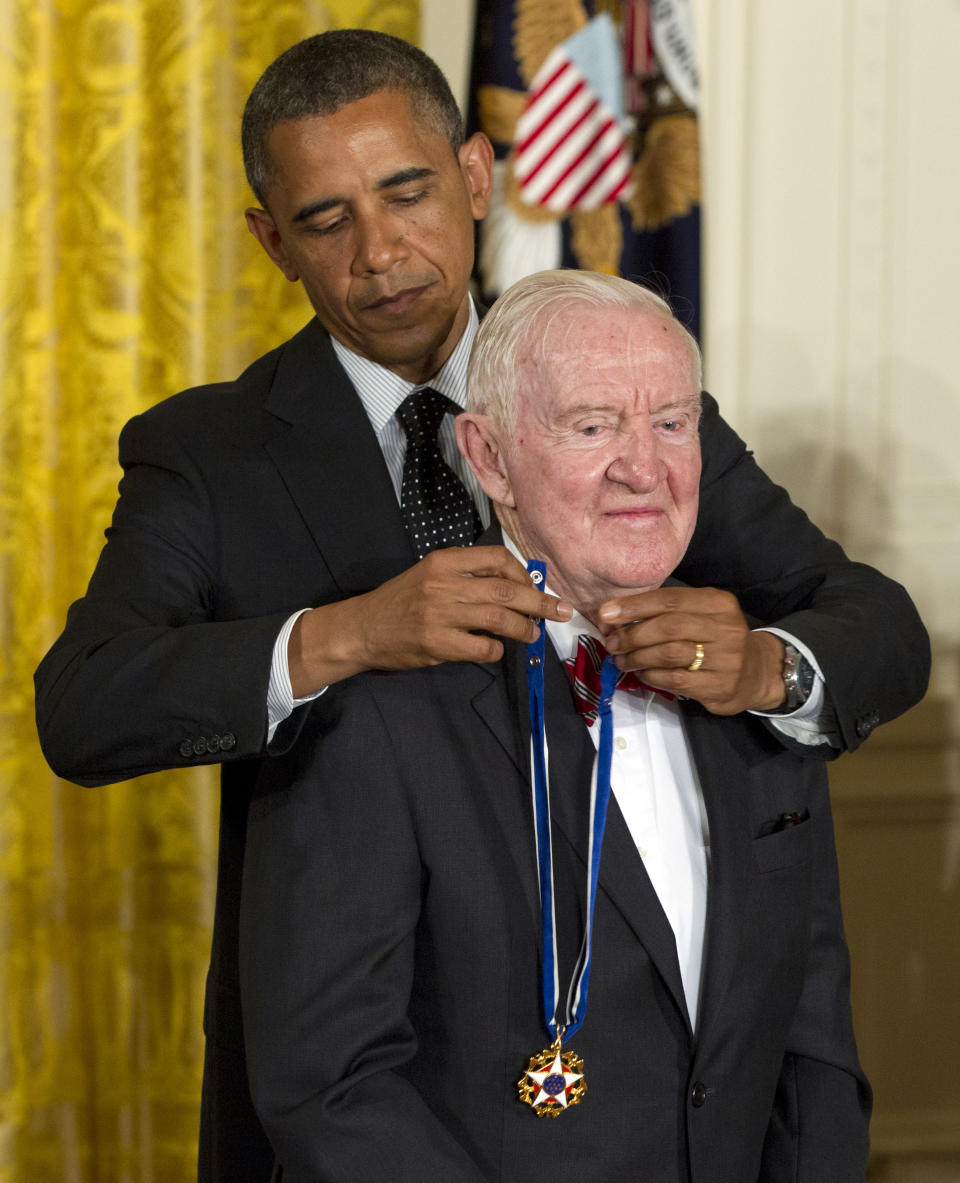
left=473, top=645, right=689, bottom=1021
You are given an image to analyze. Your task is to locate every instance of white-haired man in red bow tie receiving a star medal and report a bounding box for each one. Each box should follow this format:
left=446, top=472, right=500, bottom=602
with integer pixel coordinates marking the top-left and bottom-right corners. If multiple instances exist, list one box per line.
left=241, top=272, right=870, bottom=1183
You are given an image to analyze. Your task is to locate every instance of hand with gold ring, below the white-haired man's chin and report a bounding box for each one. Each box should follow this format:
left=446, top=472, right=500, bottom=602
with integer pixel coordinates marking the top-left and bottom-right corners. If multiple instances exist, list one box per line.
left=600, top=588, right=785, bottom=715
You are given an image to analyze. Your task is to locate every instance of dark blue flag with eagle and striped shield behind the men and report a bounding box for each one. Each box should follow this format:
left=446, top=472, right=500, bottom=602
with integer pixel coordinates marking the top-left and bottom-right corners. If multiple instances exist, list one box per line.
left=469, top=0, right=700, bottom=336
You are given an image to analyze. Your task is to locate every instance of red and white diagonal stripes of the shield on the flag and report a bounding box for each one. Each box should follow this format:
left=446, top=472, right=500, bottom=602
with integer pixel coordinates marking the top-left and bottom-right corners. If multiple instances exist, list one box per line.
left=514, top=46, right=631, bottom=213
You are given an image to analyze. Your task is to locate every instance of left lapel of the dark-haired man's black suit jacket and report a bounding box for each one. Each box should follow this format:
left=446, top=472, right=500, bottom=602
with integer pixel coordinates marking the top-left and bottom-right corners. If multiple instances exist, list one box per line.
left=265, top=319, right=414, bottom=596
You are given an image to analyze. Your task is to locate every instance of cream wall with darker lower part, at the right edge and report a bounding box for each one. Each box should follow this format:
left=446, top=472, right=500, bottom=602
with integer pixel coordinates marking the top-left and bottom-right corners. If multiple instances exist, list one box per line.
left=694, top=18, right=960, bottom=1154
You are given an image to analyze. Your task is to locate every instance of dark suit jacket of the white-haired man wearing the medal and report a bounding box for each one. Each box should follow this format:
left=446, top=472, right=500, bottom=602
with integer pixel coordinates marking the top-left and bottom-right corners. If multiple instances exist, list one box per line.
left=240, top=646, right=870, bottom=1183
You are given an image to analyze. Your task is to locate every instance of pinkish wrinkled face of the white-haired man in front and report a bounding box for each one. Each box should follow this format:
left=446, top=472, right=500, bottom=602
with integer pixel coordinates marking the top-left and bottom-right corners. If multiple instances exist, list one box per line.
left=487, top=308, right=700, bottom=615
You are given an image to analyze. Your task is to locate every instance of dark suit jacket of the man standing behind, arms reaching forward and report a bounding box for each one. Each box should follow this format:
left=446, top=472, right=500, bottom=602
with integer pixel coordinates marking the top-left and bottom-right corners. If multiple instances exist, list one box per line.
left=37, top=321, right=929, bottom=1183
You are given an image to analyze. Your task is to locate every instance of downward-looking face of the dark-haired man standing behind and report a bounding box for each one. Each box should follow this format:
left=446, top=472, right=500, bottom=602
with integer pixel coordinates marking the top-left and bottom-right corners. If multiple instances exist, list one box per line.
left=246, top=90, right=492, bottom=382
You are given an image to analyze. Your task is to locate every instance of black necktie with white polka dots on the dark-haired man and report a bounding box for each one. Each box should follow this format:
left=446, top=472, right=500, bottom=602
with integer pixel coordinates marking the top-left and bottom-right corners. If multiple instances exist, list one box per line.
left=397, top=386, right=482, bottom=558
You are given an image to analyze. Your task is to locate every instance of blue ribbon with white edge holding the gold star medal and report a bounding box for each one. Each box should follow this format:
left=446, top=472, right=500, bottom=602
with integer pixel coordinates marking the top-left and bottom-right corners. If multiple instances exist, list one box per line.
left=527, top=558, right=620, bottom=1040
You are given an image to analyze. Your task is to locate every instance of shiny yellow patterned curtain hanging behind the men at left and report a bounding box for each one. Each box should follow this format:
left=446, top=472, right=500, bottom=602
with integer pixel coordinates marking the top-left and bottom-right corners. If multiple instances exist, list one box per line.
left=0, top=0, right=418, bottom=1183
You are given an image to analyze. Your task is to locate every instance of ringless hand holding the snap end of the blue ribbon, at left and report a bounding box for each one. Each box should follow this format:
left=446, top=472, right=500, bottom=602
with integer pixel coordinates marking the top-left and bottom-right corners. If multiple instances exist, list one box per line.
left=288, top=547, right=572, bottom=698
